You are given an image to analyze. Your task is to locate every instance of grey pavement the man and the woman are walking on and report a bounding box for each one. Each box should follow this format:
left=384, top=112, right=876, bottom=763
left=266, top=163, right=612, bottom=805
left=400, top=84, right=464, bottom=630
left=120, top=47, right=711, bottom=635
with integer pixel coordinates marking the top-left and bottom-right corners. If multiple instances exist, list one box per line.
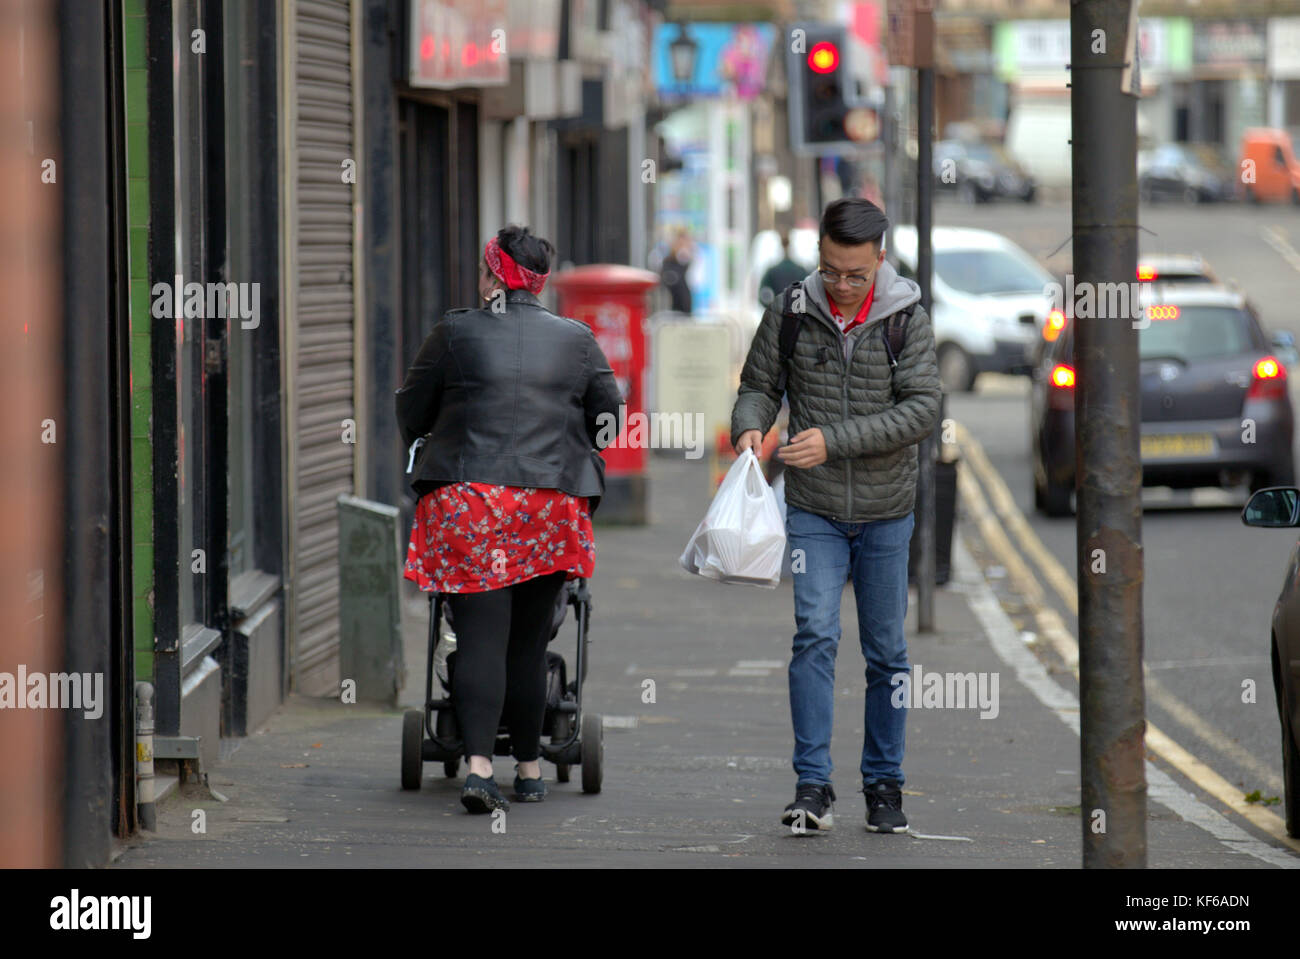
left=112, top=454, right=1286, bottom=868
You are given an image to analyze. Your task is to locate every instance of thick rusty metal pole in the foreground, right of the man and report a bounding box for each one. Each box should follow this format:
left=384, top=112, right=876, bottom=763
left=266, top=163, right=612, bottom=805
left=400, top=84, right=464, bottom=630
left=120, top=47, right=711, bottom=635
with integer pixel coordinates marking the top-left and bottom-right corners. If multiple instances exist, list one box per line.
left=1070, top=0, right=1147, bottom=868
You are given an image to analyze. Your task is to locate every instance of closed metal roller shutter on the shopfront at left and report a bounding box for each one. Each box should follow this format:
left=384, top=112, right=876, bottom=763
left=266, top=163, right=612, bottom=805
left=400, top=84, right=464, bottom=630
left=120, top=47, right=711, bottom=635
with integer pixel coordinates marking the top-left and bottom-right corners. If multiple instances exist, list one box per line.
left=290, top=0, right=356, bottom=695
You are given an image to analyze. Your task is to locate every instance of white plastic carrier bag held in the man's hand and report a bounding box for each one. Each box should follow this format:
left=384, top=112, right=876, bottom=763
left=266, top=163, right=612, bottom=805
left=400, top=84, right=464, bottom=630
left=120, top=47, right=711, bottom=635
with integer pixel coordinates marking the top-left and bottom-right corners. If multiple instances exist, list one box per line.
left=681, top=450, right=785, bottom=589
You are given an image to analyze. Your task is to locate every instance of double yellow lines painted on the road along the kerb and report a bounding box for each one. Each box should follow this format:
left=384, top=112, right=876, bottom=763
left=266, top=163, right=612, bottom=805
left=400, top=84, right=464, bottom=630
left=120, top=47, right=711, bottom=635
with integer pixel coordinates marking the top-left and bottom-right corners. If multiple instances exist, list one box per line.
left=953, top=421, right=1300, bottom=852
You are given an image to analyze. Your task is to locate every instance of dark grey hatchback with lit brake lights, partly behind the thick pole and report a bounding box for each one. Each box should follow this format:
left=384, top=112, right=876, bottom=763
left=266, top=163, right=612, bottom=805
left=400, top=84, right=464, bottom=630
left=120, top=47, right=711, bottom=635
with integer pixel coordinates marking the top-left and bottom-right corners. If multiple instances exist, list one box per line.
left=1030, top=283, right=1295, bottom=516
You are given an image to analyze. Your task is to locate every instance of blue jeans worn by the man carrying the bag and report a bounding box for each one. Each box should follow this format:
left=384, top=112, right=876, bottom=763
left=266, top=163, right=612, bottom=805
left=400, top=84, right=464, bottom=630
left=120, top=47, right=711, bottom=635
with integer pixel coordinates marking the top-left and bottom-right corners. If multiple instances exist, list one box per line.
left=785, top=505, right=915, bottom=785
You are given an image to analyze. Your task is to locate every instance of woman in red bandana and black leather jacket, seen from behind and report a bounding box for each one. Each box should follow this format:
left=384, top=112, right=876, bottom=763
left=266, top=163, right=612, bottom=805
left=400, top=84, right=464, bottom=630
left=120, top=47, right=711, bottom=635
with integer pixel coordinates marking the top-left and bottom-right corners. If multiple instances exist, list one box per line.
left=397, top=226, right=621, bottom=812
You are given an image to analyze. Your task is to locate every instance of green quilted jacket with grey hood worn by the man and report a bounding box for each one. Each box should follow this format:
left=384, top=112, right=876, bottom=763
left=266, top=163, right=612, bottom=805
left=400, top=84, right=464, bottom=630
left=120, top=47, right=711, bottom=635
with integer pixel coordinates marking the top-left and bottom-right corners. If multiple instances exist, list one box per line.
left=731, top=262, right=941, bottom=522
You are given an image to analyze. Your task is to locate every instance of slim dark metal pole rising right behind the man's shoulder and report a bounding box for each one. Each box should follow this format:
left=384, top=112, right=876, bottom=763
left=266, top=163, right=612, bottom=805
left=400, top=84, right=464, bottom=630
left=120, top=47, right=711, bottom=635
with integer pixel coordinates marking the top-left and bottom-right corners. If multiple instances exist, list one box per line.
left=914, top=66, right=935, bottom=633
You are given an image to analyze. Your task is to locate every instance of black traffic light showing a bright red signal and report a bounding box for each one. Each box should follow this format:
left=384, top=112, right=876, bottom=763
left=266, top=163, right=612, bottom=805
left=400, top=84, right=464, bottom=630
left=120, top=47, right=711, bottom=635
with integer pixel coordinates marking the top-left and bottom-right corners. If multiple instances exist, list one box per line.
left=785, top=23, right=854, bottom=153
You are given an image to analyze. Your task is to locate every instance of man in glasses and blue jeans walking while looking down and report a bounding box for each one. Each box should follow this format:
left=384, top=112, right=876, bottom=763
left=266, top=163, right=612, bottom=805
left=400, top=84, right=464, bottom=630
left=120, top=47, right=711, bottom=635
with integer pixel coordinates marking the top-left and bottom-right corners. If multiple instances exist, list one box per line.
left=731, top=198, right=940, bottom=833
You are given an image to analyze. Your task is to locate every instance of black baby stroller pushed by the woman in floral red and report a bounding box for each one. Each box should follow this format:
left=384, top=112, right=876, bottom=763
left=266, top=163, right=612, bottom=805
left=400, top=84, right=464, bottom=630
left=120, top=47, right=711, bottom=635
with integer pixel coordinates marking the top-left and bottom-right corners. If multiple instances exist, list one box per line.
left=402, top=580, right=605, bottom=793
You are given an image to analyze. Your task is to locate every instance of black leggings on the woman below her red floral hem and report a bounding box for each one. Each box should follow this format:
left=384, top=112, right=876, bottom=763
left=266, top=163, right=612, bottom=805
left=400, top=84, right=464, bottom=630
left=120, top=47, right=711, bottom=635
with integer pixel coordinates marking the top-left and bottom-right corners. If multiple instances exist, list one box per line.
left=446, top=570, right=566, bottom=763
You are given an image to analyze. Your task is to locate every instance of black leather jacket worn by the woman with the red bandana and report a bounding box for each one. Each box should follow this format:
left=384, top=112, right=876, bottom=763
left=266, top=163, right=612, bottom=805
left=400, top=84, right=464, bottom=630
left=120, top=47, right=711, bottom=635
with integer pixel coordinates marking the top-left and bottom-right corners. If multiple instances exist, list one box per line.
left=397, top=290, right=623, bottom=512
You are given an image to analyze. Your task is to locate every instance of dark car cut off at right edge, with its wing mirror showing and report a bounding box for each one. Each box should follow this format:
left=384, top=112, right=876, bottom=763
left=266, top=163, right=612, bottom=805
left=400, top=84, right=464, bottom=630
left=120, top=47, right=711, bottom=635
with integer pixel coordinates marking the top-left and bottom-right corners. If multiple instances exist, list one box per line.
left=1242, top=486, right=1300, bottom=838
